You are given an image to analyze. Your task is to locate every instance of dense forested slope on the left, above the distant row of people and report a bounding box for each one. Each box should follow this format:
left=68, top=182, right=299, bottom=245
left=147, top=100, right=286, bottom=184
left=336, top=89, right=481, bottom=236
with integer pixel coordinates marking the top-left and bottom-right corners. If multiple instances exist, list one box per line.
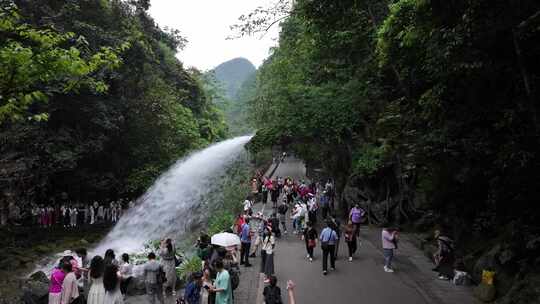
left=0, top=0, right=227, bottom=204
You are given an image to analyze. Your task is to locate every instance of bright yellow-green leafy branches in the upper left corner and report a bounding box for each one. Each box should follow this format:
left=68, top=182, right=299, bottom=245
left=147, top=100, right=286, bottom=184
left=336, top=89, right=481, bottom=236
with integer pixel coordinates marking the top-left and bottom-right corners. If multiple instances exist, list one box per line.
left=0, top=1, right=125, bottom=124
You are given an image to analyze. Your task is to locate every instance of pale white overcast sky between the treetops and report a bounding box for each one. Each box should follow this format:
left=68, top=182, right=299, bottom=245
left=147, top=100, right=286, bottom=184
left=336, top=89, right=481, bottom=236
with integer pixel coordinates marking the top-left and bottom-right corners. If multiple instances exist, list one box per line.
left=150, top=0, right=279, bottom=70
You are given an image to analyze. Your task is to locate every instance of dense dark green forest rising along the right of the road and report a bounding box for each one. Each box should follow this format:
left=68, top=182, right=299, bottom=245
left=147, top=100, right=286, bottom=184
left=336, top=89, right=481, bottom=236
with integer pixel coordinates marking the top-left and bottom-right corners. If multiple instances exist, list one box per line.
left=245, top=0, right=540, bottom=303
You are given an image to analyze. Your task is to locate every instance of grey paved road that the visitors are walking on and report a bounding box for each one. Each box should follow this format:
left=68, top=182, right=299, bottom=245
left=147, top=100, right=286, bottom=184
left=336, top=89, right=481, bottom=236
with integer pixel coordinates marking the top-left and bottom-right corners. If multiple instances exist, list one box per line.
left=267, top=158, right=475, bottom=304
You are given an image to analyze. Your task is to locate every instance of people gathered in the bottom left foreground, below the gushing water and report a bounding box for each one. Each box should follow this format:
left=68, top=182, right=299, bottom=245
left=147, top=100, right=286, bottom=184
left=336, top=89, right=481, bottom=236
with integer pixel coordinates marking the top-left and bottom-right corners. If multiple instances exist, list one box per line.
left=45, top=239, right=178, bottom=304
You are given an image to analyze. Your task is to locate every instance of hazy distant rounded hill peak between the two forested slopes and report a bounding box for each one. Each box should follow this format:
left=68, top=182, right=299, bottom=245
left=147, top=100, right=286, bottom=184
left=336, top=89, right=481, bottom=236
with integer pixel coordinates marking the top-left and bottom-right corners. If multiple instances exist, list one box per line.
left=213, top=58, right=256, bottom=100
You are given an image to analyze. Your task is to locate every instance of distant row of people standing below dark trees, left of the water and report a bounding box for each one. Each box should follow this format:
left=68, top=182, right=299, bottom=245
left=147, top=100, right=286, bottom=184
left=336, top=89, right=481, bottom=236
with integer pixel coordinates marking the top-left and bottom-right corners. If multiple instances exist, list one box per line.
left=5, top=199, right=133, bottom=228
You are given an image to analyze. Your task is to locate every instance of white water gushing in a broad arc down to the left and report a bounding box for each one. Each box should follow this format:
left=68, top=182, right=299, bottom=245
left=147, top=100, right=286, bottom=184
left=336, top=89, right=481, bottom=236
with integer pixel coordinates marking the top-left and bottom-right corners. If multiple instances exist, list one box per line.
left=92, top=136, right=251, bottom=254
